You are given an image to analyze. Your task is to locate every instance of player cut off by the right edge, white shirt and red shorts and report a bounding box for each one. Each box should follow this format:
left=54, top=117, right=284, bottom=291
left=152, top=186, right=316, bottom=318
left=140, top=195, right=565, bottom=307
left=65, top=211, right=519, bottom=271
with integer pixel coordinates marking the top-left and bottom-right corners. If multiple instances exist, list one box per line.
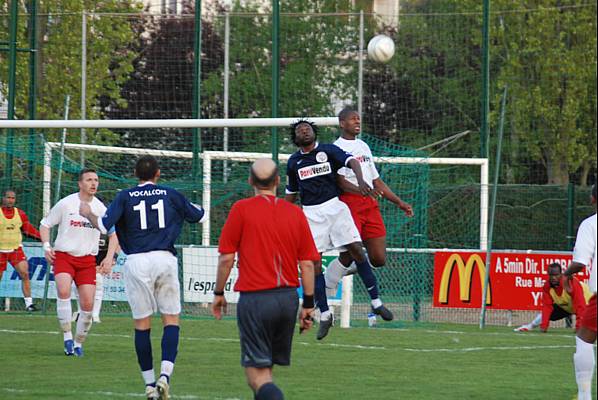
left=564, top=184, right=598, bottom=400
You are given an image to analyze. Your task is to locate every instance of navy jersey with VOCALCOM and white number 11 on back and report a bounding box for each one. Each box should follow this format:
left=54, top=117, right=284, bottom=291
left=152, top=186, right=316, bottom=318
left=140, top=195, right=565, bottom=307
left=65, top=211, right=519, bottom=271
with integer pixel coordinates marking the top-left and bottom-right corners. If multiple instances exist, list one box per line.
left=98, top=182, right=206, bottom=255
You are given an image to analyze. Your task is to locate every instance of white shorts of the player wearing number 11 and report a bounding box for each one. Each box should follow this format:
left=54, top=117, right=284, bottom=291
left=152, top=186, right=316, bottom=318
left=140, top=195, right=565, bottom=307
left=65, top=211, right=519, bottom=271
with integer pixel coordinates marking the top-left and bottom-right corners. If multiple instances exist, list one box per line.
left=124, top=251, right=181, bottom=319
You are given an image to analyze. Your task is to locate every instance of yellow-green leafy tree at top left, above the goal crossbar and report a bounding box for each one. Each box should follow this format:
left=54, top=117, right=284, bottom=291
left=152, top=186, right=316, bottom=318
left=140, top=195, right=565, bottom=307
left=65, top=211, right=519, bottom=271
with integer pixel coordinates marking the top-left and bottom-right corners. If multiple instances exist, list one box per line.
left=0, top=0, right=139, bottom=128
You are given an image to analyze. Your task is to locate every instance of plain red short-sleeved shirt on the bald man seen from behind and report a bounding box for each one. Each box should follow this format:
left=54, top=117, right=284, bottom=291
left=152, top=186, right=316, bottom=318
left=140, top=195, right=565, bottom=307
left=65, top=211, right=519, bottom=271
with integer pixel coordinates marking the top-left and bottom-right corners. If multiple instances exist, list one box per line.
left=218, top=195, right=320, bottom=292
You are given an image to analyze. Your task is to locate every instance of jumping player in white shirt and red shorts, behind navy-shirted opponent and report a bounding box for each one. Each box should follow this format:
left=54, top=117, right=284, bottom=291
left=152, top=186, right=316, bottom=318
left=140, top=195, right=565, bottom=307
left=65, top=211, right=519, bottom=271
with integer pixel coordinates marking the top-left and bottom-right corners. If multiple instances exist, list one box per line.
left=326, top=107, right=413, bottom=295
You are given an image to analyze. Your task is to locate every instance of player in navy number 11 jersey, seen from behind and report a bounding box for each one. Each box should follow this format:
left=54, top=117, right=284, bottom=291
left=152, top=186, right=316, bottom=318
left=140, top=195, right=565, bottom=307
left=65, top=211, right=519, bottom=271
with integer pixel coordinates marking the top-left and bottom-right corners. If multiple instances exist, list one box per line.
left=80, top=156, right=206, bottom=399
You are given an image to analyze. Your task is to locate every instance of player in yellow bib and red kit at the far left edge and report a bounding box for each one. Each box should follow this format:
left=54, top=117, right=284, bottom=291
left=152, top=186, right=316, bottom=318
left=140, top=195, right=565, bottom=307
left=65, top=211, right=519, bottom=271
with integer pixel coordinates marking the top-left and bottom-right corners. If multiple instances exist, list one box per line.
left=0, top=190, right=39, bottom=311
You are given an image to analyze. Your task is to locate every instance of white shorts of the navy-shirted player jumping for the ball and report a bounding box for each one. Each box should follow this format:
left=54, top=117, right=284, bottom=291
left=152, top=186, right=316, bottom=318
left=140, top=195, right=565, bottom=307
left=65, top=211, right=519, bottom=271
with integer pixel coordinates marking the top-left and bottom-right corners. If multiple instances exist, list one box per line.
left=303, top=197, right=361, bottom=253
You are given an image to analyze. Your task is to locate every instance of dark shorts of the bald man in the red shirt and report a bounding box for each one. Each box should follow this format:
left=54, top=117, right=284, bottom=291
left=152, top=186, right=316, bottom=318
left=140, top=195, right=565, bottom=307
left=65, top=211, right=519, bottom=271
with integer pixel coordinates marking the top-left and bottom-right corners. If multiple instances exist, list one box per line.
left=237, top=288, right=299, bottom=368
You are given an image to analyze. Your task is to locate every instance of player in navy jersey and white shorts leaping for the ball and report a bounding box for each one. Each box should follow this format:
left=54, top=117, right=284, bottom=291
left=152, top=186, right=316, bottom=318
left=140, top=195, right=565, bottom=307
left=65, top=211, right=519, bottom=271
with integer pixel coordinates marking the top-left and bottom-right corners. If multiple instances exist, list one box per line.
left=286, top=120, right=393, bottom=340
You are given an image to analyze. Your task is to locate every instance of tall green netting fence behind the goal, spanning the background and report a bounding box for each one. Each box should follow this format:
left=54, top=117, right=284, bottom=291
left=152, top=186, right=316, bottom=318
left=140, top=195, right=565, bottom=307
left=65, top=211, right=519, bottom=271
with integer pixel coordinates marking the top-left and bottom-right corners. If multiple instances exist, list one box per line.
left=0, top=0, right=597, bottom=322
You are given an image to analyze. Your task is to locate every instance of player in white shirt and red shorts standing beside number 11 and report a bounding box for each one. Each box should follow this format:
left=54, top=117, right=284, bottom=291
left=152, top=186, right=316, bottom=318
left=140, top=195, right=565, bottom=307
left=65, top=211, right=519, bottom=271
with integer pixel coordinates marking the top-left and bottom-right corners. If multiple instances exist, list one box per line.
left=39, top=169, right=117, bottom=357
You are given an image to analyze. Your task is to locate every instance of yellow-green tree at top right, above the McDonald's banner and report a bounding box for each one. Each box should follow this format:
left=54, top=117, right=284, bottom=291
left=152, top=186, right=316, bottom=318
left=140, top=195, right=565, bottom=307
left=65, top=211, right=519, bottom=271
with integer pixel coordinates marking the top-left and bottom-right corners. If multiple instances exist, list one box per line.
left=493, top=0, right=596, bottom=185
